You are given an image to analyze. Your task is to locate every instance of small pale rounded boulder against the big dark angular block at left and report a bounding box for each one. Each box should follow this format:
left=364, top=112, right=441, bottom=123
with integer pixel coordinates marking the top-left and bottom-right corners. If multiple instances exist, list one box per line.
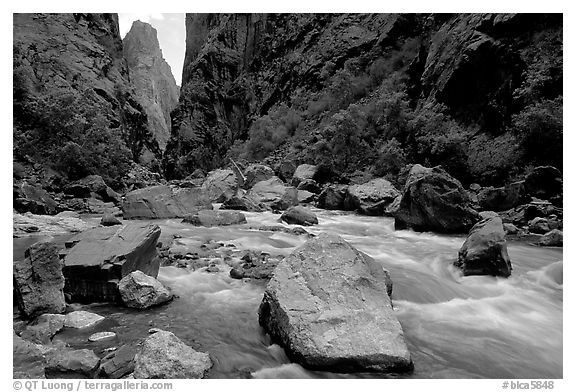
left=118, top=271, right=173, bottom=309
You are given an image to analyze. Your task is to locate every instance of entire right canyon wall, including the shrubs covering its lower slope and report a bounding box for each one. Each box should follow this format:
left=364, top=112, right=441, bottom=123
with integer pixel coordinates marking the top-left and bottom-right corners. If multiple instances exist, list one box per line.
left=164, top=14, right=562, bottom=182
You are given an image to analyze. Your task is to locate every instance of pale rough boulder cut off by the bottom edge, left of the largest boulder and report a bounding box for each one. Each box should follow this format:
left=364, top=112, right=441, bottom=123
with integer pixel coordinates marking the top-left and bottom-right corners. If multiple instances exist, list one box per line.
left=134, top=330, right=212, bottom=379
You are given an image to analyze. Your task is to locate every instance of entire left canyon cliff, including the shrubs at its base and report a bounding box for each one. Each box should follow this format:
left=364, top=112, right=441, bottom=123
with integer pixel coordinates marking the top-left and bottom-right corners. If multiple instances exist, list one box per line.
left=13, top=14, right=161, bottom=183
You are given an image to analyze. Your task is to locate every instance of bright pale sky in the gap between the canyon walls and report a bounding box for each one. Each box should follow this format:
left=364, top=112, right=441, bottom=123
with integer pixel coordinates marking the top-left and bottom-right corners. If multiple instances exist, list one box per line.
left=118, top=13, right=186, bottom=86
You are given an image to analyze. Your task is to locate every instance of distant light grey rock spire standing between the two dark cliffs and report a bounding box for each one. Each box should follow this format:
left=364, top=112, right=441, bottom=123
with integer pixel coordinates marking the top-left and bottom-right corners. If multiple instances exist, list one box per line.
left=123, top=21, right=179, bottom=155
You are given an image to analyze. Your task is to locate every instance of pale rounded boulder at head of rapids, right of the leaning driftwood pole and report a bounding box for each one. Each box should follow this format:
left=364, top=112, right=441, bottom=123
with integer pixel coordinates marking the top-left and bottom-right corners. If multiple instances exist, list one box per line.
left=248, top=177, right=298, bottom=210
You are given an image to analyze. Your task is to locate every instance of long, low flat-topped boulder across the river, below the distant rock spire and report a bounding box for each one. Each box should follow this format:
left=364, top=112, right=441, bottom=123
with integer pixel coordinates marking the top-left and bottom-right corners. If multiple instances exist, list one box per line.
left=122, top=185, right=212, bottom=219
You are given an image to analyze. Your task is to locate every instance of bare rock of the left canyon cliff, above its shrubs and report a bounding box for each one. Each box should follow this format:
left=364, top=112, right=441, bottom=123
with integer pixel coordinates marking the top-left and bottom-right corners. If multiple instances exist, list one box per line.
left=13, top=14, right=161, bottom=175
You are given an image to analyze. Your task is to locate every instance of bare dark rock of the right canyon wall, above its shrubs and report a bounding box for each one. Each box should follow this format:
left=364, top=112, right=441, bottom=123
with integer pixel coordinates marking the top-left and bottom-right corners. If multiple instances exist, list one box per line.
left=164, top=14, right=562, bottom=183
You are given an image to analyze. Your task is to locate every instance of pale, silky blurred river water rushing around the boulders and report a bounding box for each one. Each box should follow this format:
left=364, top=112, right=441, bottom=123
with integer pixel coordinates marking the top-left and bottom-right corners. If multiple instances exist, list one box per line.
left=15, top=210, right=563, bottom=378
